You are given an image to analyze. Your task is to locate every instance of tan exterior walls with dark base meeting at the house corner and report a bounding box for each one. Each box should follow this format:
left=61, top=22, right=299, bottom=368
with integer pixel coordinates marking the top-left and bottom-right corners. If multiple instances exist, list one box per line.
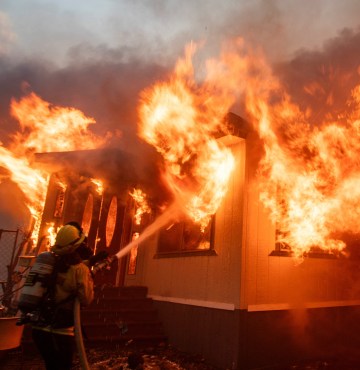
left=125, top=129, right=360, bottom=369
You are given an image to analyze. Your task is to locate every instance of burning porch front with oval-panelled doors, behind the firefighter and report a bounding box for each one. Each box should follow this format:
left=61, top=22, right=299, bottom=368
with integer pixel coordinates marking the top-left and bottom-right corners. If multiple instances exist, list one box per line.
left=36, top=149, right=148, bottom=253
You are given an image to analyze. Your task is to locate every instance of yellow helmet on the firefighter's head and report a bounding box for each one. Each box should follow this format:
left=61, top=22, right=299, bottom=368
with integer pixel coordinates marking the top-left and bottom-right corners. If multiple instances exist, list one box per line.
left=51, top=225, right=86, bottom=255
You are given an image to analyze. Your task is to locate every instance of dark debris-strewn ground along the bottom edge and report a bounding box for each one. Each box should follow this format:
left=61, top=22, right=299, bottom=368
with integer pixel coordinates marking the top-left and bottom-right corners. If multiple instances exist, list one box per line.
left=0, top=345, right=360, bottom=370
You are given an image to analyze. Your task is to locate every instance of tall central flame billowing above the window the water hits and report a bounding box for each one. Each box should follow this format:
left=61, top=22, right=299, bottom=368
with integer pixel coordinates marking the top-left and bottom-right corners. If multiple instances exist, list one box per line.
left=139, top=44, right=234, bottom=229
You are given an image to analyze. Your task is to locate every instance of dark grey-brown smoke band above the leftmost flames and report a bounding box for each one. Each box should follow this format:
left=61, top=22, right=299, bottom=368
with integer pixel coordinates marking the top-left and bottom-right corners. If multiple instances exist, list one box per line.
left=0, top=54, right=166, bottom=145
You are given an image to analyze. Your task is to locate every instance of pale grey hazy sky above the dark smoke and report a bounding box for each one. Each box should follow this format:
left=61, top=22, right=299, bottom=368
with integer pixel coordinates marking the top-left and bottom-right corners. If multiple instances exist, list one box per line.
left=0, top=0, right=360, bottom=66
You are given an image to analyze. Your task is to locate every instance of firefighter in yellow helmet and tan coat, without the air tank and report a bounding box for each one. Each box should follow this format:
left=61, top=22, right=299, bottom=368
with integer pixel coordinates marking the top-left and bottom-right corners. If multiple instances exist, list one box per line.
left=31, top=222, right=94, bottom=370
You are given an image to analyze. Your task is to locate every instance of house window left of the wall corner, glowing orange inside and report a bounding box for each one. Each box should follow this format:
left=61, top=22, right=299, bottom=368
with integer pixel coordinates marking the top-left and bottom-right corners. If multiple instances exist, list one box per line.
left=156, top=217, right=216, bottom=257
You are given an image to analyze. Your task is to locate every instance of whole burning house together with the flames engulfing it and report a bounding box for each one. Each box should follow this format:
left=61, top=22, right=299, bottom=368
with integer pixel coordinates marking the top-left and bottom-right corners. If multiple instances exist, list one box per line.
left=2, top=40, right=360, bottom=369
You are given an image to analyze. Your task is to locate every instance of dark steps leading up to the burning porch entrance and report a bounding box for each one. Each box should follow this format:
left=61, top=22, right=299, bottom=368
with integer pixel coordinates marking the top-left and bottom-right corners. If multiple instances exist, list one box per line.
left=81, top=286, right=167, bottom=345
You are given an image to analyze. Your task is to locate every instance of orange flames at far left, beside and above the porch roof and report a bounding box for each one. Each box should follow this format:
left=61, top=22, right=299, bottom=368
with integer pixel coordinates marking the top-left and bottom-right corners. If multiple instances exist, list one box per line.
left=0, top=93, right=106, bottom=244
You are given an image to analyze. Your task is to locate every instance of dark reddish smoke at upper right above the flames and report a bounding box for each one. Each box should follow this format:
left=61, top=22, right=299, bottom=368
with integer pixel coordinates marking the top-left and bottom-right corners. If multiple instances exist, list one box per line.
left=275, top=29, right=360, bottom=124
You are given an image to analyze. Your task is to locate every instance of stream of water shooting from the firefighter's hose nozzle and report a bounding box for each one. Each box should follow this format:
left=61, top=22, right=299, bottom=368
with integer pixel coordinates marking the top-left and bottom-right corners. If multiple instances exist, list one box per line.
left=115, top=202, right=182, bottom=258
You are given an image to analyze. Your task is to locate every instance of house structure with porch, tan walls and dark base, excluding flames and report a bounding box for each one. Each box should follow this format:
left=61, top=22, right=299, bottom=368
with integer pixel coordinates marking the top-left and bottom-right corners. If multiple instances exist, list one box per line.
left=26, top=108, right=360, bottom=369
